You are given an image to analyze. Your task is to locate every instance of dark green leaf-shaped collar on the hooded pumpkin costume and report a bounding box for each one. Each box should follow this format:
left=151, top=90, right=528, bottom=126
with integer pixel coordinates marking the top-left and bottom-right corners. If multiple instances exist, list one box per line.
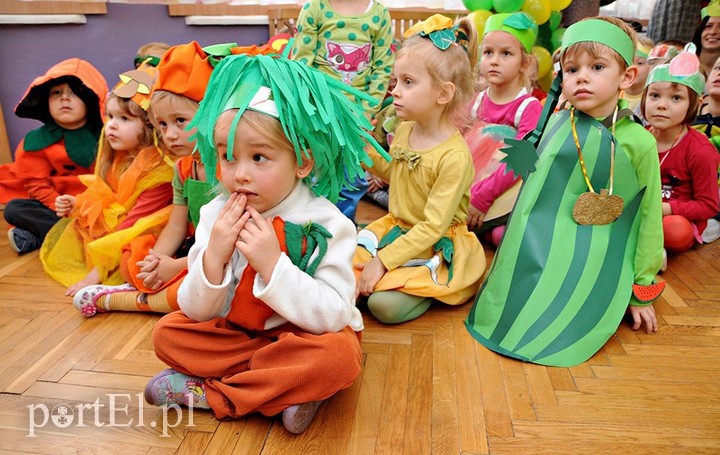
left=23, top=123, right=99, bottom=167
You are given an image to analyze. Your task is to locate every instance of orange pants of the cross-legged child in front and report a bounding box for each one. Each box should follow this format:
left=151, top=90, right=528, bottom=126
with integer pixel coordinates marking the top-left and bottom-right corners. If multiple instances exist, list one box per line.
left=153, top=311, right=362, bottom=419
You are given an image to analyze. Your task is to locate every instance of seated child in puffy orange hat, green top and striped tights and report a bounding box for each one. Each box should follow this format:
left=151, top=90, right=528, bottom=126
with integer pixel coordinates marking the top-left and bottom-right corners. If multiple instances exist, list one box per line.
left=73, top=41, right=215, bottom=317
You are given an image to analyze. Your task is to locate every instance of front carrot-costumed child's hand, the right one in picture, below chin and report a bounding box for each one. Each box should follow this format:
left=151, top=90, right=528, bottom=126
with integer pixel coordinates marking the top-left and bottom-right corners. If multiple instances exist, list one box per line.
left=235, top=207, right=280, bottom=282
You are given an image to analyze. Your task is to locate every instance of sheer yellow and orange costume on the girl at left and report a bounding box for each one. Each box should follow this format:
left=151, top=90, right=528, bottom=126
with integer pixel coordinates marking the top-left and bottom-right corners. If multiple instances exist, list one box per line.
left=40, top=147, right=173, bottom=286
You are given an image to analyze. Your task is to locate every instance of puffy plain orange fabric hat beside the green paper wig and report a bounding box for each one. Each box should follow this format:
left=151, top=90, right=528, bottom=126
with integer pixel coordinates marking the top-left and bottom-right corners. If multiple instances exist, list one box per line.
left=153, top=41, right=213, bottom=102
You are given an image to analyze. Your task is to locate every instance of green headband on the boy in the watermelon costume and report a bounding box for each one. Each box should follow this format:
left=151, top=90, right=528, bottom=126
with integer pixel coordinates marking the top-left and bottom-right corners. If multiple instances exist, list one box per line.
left=561, top=19, right=635, bottom=66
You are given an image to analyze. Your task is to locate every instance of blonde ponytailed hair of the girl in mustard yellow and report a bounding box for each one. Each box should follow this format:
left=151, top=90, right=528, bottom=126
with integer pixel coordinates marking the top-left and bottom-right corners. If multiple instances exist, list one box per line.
left=395, top=17, right=478, bottom=116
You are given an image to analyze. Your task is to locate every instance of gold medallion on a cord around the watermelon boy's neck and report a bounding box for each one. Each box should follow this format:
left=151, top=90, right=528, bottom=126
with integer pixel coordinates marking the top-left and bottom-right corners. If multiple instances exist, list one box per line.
left=570, top=106, right=624, bottom=225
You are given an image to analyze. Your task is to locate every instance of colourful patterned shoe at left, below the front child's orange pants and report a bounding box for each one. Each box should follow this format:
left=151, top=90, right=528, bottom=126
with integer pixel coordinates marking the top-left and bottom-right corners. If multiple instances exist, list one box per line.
left=145, top=368, right=210, bottom=409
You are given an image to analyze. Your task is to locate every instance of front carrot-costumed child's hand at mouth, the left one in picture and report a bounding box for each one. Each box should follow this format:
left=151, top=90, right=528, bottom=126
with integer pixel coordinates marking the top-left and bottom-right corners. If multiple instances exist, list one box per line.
left=206, top=193, right=250, bottom=265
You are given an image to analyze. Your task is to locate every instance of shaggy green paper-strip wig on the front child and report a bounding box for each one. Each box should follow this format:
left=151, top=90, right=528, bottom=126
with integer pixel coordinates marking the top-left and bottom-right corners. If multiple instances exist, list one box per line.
left=188, top=55, right=390, bottom=202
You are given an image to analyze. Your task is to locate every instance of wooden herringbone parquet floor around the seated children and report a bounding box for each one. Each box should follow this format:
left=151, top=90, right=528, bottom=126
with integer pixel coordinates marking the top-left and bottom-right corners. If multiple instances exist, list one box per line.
left=0, top=201, right=720, bottom=455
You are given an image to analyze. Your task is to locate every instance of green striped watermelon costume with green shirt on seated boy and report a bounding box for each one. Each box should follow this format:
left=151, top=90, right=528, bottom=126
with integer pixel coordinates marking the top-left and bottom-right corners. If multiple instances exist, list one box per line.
left=466, top=106, right=663, bottom=366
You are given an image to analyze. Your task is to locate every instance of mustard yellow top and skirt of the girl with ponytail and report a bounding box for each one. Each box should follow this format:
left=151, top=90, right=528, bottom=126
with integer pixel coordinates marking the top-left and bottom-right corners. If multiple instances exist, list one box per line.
left=353, top=122, right=485, bottom=305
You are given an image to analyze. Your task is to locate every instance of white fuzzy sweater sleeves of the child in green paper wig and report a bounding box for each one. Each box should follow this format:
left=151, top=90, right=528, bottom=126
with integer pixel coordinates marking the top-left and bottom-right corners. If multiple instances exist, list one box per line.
left=178, top=183, right=363, bottom=334
